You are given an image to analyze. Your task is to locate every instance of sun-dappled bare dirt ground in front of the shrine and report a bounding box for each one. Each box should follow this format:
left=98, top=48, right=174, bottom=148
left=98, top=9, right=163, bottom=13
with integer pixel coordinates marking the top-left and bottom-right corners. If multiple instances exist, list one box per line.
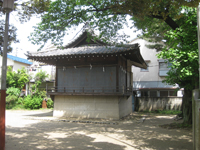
left=6, top=110, right=192, bottom=150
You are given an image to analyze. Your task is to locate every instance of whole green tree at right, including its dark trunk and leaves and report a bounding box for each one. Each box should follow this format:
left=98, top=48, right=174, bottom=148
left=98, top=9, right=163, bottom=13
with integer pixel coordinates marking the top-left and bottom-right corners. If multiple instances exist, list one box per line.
left=134, top=7, right=199, bottom=124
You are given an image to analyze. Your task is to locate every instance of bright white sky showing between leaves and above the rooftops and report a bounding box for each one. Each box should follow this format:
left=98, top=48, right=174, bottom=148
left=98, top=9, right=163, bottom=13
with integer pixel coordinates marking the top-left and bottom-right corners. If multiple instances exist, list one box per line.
left=9, top=12, right=137, bottom=58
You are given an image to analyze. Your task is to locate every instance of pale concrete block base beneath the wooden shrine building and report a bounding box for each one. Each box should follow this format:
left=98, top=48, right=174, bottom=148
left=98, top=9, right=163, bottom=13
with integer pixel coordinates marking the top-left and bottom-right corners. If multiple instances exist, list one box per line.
left=53, top=95, right=132, bottom=119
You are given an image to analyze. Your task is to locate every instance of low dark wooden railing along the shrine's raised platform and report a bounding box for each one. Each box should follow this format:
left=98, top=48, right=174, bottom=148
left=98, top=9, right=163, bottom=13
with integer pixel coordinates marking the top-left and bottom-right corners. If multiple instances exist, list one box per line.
left=46, top=86, right=132, bottom=95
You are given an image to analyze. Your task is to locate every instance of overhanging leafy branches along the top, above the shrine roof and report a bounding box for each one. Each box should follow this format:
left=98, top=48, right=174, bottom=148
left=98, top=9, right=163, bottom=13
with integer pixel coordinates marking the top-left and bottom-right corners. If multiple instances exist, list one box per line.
left=30, top=0, right=198, bottom=49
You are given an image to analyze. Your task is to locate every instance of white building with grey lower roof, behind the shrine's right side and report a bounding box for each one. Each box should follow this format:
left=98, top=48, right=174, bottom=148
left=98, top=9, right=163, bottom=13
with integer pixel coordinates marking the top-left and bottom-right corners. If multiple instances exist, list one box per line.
left=130, top=38, right=182, bottom=97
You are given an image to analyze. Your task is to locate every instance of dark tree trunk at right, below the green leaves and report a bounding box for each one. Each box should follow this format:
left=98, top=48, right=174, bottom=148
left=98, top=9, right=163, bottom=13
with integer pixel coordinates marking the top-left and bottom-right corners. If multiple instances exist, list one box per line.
left=182, top=89, right=192, bottom=124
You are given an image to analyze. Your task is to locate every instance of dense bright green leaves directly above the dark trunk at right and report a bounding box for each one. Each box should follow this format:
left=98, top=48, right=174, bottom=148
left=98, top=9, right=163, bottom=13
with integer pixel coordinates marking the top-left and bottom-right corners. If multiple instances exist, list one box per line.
left=159, top=8, right=199, bottom=90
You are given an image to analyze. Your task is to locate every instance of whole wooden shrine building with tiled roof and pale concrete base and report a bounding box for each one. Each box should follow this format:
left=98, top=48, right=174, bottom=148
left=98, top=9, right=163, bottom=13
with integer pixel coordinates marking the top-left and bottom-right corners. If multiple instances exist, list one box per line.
left=27, top=31, right=147, bottom=119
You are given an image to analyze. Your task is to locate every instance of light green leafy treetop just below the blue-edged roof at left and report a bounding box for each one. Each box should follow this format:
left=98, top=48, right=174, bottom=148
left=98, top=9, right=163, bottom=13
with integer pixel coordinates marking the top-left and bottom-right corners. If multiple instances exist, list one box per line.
left=6, top=67, right=30, bottom=89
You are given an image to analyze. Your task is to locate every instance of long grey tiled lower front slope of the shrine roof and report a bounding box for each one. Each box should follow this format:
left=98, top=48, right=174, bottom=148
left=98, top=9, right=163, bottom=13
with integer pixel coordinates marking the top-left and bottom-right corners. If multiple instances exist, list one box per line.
left=27, top=44, right=139, bottom=57
